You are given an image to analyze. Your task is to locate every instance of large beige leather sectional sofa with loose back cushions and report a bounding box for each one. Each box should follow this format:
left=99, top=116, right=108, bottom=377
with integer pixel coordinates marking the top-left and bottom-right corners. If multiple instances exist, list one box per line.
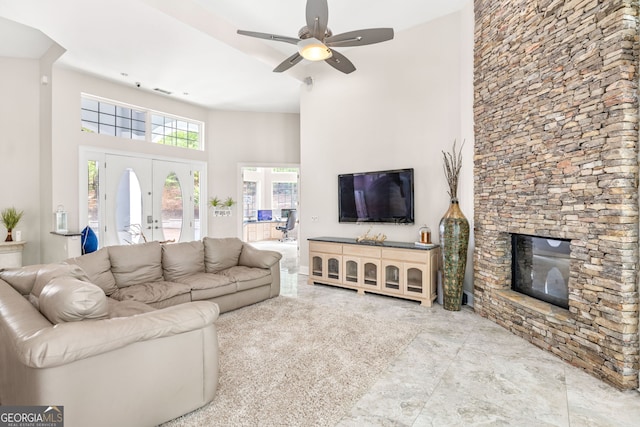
left=0, top=237, right=281, bottom=427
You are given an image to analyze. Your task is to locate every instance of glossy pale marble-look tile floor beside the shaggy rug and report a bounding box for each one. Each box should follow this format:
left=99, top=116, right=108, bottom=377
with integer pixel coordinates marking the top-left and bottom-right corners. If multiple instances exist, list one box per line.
left=250, top=243, right=640, bottom=427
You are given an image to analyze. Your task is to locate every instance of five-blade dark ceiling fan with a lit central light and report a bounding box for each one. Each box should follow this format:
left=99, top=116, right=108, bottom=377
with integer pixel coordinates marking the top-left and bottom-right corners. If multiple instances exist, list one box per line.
left=238, top=0, right=393, bottom=74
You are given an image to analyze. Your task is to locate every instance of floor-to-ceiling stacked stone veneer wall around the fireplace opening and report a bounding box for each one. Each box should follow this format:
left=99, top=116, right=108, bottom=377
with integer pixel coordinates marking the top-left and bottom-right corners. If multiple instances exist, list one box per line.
left=474, top=0, right=639, bottom=389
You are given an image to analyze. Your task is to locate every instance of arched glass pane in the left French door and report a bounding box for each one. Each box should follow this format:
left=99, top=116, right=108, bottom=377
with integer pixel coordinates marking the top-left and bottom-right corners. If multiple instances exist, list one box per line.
left=116, top=169, right=146, bottom=245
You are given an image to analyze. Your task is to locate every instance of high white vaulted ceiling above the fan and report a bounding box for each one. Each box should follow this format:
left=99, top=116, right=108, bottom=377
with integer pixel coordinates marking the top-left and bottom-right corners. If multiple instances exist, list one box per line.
left=0, top=0, right=470, bottom=112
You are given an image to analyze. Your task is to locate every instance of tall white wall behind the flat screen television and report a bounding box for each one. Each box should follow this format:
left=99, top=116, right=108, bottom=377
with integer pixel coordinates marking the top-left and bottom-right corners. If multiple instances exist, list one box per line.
left=300, top=2, right=473, bottom=298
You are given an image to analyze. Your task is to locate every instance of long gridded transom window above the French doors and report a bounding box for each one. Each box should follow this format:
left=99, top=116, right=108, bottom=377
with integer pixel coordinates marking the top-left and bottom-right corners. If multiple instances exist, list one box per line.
left=80, top=94, right=204, bottom=150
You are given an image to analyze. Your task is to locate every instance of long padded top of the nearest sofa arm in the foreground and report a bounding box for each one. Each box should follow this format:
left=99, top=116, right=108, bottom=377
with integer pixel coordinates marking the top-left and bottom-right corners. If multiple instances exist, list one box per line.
left=10, top=301, right=219, bottom=368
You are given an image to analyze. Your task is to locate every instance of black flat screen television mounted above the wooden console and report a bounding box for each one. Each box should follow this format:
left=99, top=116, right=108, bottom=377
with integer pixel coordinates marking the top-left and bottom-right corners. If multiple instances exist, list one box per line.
left=338, top=169, right=415, bottom=224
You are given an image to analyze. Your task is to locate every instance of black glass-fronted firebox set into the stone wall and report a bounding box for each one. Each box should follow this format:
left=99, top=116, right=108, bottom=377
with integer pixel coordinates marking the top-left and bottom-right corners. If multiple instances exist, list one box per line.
left=511, top=234, right=571, bottom=309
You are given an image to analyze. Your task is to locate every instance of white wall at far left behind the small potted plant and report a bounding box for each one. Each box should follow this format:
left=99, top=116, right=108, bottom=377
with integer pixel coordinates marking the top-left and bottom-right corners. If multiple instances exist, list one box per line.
left=0, top=57, right=40, bottom=264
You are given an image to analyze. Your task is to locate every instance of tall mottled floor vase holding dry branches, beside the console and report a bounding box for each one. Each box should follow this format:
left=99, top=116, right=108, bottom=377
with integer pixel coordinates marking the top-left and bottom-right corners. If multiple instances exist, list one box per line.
left=440, top=141, right=469, bottom=311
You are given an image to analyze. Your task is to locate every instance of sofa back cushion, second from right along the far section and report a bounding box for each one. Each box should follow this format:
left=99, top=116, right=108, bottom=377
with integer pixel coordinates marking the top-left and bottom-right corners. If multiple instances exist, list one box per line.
left=162, top=241, right=204, bottom=282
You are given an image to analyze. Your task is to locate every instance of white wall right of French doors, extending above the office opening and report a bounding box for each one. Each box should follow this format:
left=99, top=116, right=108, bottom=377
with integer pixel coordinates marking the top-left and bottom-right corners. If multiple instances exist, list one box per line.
left=207, top=111, right=300, bottom=238
